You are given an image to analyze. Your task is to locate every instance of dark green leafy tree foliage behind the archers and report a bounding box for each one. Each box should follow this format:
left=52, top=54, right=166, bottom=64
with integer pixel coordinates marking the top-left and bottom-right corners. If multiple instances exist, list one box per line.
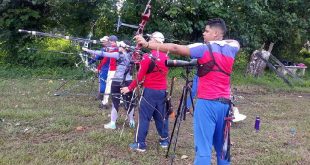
left=0, top=0, right=310, bottom=66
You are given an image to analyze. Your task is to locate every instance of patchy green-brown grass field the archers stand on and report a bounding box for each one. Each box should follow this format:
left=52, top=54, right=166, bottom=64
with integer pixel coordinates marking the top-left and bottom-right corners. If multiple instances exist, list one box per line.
left=0, top=78, right=310, bottom=165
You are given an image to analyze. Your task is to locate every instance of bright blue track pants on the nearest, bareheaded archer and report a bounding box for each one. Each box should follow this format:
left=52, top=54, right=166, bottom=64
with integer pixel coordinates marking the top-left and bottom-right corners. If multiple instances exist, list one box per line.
left=194, top=99, right=230, bottom=165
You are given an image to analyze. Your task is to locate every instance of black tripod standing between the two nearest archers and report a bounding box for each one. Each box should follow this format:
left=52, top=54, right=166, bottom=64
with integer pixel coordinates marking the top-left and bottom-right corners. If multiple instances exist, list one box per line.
left=166, top=66, right=194, bottom=164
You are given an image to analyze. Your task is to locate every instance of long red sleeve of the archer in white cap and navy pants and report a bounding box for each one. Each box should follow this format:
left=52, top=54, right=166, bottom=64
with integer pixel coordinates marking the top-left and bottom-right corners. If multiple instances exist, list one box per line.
left=128, top=55, right=151, bottom=91
